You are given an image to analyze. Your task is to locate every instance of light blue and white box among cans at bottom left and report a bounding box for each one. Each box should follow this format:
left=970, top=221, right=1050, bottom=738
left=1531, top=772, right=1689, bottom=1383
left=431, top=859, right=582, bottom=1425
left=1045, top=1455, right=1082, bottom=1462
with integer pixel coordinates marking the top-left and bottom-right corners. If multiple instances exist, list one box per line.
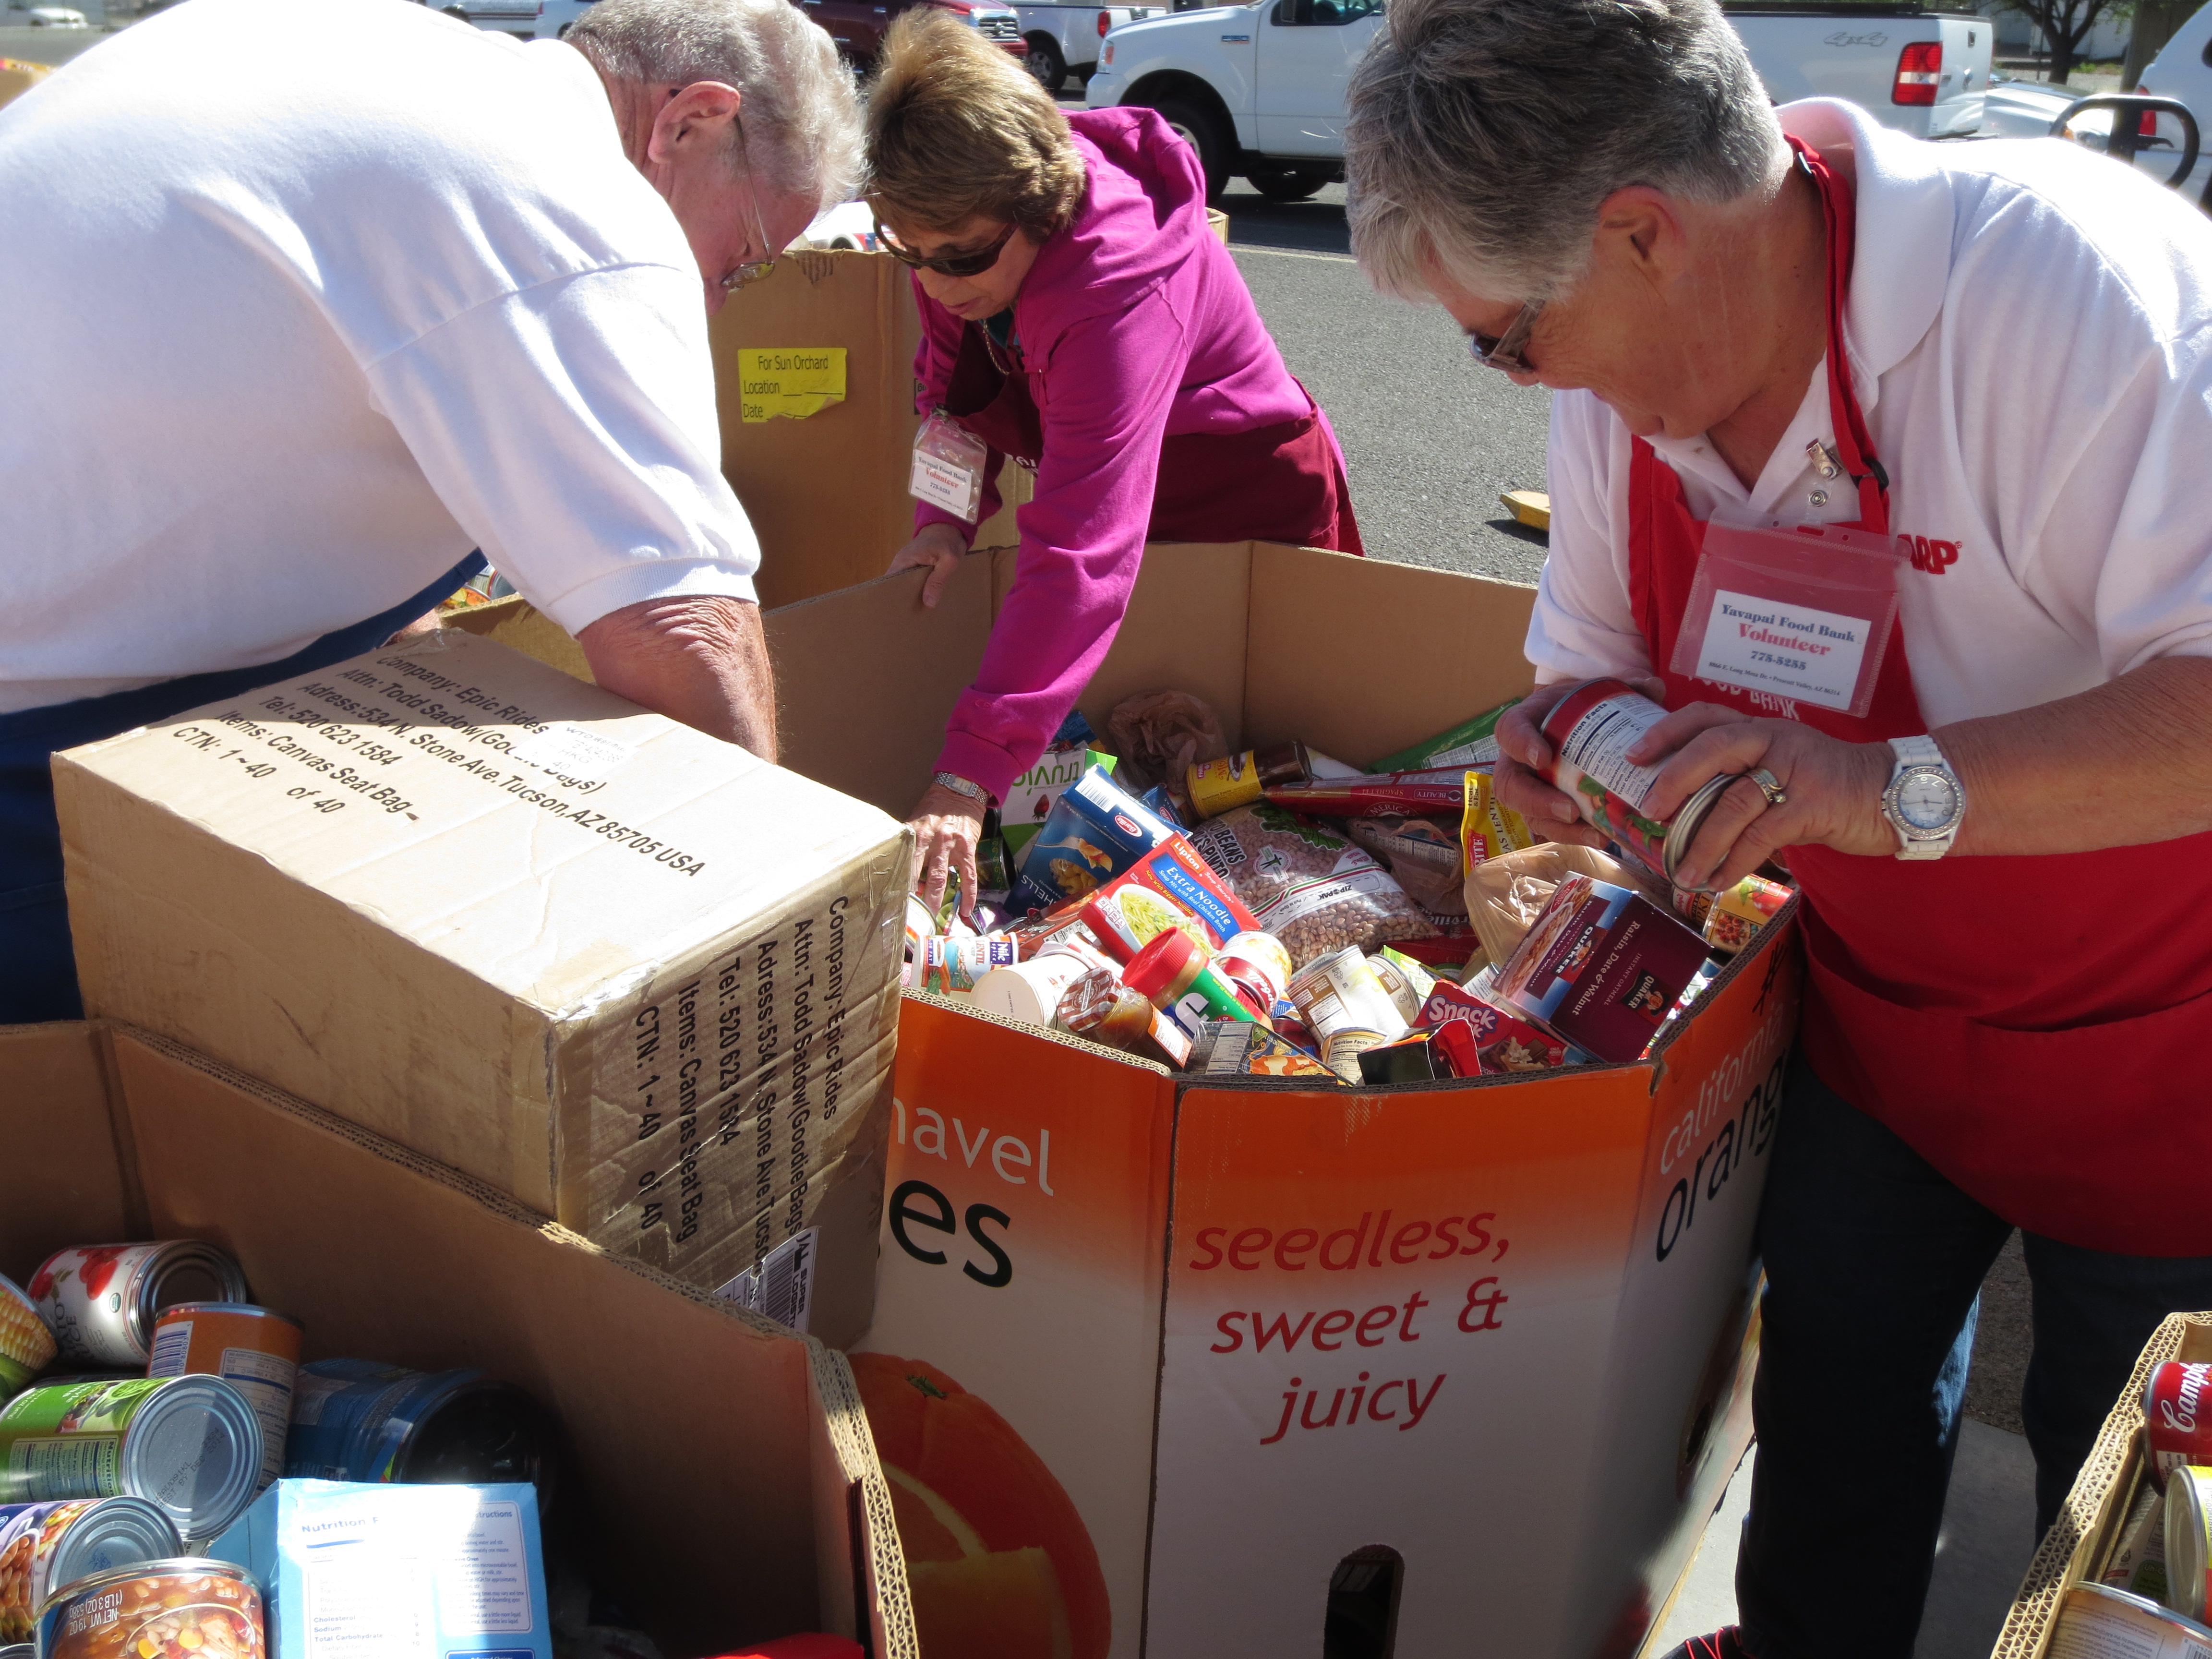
left=206, top=1480, right=553, bottom=1659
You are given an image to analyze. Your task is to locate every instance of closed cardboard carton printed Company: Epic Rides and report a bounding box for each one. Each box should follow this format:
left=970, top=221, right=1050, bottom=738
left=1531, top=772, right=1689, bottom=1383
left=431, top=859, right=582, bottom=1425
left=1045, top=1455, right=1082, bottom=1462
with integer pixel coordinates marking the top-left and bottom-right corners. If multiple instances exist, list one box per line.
left=55, top=633, right=909, bottom=1340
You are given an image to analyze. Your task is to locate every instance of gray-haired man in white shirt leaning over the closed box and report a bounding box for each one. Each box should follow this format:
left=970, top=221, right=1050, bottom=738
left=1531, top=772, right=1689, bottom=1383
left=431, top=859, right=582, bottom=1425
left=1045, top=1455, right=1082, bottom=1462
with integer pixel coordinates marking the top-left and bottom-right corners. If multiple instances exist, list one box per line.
left=0, top=0, right=861, bottom=1022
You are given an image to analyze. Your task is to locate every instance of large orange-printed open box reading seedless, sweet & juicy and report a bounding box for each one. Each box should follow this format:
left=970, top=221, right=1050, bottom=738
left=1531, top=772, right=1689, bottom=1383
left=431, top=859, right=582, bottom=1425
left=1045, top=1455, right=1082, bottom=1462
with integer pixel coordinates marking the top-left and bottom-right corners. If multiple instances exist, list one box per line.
left=458, top=542, right=1801, bottom=1659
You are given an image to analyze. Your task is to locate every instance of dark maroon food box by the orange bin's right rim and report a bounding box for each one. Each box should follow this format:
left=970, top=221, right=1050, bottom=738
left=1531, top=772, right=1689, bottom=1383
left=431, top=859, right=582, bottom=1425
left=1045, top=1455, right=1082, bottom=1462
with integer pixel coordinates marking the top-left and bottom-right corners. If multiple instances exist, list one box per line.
left=1498, top=876, right=1706, bottom=1062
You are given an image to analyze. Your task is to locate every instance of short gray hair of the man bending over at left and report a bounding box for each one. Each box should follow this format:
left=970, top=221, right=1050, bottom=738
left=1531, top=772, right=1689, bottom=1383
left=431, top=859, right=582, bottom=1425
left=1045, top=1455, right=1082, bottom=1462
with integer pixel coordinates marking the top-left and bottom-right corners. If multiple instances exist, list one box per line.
left=568, top=0, right=861, bottom=210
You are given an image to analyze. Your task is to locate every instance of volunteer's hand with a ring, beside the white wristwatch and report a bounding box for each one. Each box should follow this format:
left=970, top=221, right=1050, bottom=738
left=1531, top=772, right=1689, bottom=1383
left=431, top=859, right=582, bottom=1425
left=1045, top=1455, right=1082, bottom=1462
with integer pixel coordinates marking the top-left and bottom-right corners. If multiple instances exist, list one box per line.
left=1628, top=703, right=1898, bottom=891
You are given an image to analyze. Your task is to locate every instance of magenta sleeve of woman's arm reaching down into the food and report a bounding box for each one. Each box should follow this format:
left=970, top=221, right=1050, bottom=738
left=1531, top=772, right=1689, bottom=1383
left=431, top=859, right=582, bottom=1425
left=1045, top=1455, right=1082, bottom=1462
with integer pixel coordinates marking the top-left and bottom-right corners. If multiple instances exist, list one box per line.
left=938, top=307, right=1188, bottom=801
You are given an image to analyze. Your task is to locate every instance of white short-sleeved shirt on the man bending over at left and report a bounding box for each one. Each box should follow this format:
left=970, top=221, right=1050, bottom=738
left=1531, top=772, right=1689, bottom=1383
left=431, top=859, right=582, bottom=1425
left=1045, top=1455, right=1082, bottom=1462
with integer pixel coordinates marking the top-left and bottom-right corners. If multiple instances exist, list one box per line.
left=0, top=0, right=759, bottom=712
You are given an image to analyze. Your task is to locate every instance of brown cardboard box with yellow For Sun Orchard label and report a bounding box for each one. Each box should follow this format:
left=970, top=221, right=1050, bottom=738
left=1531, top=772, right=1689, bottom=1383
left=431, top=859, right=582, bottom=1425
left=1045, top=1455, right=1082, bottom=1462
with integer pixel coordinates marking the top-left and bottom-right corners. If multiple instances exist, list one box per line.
left=710, top=250, right=1031, bottom=606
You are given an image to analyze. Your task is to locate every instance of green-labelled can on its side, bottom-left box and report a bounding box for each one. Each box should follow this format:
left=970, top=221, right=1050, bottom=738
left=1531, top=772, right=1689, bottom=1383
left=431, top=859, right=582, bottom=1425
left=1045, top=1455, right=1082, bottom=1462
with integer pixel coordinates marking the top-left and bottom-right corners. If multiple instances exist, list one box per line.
left=0, top=1376, right=261, bottom=1538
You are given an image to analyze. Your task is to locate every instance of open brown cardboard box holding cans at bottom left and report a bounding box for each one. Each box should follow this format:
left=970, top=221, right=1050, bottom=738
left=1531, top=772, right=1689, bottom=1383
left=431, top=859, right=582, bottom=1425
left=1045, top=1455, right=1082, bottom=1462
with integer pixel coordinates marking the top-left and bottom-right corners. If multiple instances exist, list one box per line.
left=0, top=1024, right=918, bottom=1659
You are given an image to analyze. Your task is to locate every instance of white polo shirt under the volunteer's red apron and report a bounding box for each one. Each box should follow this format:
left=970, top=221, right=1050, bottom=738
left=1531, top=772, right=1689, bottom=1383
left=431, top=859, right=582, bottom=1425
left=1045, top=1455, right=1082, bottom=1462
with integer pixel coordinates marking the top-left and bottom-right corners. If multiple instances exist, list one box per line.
left=1530, top=100, right=2212, bottom=728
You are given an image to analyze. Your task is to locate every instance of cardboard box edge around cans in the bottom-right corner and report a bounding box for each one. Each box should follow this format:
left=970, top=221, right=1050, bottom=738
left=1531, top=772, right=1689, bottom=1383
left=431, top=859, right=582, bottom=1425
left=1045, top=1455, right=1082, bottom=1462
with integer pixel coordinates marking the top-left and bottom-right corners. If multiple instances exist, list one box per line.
left=1991, top=1314, right=2212, bottom=1659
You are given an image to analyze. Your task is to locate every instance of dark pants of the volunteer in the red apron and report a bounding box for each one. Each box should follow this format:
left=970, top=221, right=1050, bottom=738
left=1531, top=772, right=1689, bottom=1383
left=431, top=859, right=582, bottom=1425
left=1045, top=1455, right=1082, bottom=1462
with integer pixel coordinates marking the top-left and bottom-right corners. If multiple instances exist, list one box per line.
left=1736, top=1059, right=2212, bottom=1659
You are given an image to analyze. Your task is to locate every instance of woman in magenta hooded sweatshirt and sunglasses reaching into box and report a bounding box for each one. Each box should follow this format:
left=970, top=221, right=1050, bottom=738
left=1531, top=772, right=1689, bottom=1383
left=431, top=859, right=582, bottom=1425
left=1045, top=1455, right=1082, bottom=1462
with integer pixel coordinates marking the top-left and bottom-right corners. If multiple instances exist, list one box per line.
left=867, top=7, right=1360, bottom=907
